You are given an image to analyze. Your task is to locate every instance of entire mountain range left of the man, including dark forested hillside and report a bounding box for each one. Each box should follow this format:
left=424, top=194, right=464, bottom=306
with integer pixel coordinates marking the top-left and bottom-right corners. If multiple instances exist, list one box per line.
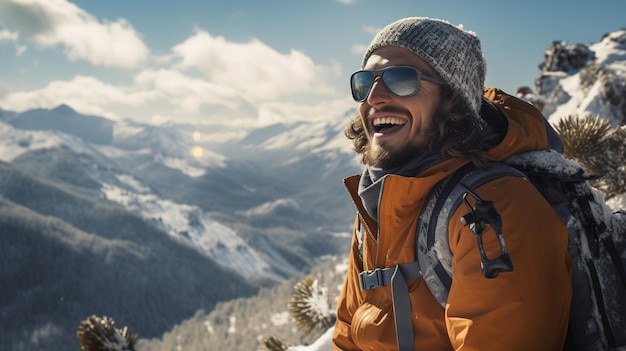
left=0, top=101, right=359, bottom=349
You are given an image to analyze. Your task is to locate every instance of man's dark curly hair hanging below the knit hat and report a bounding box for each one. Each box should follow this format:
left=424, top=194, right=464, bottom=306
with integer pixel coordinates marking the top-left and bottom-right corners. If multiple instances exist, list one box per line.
left=344, top=87, right=486, bottom=167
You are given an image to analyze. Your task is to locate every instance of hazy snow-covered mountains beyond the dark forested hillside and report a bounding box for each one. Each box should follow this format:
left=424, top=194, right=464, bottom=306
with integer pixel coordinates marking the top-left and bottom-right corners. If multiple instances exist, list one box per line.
left=0, top=105, right=358, bottom=280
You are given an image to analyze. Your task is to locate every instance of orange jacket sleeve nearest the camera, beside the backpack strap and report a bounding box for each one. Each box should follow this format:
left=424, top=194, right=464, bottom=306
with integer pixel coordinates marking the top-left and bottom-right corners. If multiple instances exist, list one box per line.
left=446, top=177, right=571, bottom=351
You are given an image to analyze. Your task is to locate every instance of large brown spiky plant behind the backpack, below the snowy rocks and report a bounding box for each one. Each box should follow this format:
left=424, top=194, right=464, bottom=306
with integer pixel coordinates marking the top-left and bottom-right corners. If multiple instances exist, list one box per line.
left=555, top=116, right=626, bottom=199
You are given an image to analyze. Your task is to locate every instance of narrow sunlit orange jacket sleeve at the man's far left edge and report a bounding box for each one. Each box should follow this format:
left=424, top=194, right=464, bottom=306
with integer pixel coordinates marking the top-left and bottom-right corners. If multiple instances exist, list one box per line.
left=333, top=218, right=363, bottom=351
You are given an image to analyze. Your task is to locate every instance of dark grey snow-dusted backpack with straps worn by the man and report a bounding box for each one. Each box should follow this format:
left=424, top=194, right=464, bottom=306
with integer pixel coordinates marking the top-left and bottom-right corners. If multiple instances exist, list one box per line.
left=359, top=99, right=626, bottom=351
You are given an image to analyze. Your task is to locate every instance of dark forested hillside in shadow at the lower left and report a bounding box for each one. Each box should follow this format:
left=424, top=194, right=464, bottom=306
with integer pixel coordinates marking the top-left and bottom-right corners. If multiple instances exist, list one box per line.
left=0, top=164, right=258, bottom=350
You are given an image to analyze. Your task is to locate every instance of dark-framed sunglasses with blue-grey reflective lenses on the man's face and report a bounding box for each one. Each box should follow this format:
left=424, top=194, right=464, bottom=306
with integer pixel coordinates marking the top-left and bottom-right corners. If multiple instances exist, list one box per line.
left=350, top=66, right=445, bottom=102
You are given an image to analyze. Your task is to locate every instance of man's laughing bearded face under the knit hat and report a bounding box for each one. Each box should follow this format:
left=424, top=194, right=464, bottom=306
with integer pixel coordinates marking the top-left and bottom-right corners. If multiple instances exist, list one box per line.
left=359, top=46, right=441, bottom=168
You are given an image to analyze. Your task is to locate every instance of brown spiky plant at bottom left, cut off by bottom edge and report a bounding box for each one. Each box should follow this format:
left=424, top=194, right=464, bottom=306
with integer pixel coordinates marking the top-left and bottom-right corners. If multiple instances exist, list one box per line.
left=76, top=315, right=137, bottom=351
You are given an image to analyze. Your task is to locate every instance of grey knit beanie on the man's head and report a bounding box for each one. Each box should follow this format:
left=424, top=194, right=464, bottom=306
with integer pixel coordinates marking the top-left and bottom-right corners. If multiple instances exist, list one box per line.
left=361, top=17, right=487, bottom=116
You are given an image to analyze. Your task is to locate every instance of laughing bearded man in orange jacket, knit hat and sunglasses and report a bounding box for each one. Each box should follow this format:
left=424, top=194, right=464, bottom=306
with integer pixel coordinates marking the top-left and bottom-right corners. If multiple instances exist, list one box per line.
left=333, top=18, right=571, bottom=351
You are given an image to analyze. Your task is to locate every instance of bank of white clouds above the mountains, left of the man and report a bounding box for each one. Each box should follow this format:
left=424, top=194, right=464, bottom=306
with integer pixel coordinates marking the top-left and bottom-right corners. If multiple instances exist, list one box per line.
left=0, top=0, right=352, bottom=125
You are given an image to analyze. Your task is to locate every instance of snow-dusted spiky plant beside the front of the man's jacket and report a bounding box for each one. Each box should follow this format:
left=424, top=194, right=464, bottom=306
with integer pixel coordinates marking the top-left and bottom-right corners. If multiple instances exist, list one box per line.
left=289, top=276, right=336, bottom=335
